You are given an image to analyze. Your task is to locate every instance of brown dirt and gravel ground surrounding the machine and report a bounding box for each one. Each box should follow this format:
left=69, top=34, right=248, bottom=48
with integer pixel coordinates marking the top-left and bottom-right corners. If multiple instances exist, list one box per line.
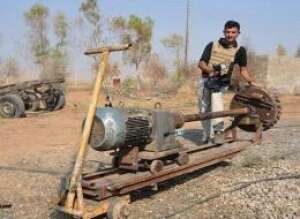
left=0, top=91, right=300, bottom=219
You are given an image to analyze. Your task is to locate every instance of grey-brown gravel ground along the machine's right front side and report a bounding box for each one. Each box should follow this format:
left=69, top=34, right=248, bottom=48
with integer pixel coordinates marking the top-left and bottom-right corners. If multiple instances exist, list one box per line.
left=128, top=120, right=300, bottom=219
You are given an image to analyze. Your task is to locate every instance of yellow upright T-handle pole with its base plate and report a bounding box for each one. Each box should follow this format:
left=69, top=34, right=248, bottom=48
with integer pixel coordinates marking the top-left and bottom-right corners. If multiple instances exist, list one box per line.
left=58, top=44, right=131, bottom=219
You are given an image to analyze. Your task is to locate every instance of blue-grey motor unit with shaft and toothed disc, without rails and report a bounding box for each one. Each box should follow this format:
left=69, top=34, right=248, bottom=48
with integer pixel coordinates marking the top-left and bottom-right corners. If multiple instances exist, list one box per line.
left=89, top=86, right=281, bottom=173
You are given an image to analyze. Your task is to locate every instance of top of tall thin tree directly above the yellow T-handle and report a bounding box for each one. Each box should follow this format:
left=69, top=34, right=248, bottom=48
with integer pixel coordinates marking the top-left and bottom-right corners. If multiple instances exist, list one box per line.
left=79, top=0, right=101, bottom=47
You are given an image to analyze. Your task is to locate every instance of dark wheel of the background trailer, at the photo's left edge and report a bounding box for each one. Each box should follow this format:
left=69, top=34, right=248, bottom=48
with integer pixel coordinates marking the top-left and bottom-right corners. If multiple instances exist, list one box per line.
left=0, top=94, right=25, bottom=118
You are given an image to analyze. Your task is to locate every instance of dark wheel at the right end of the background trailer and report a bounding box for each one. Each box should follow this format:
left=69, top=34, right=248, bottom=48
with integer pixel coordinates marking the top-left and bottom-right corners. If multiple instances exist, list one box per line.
left=45, top=89, right=66, bottom=111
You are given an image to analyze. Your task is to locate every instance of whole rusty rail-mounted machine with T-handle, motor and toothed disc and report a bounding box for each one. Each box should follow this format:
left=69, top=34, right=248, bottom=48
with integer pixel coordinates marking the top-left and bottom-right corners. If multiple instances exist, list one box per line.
left=57, top=45, right=281, bottom=219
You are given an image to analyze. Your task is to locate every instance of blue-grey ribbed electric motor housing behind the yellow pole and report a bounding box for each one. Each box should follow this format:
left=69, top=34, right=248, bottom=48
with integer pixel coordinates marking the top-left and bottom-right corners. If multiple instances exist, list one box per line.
left=89, top=107, right=152, bottom=151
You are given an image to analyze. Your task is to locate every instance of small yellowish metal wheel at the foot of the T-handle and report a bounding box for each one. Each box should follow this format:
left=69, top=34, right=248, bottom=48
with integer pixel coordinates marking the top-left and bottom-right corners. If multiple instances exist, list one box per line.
left=107, top=199, right=130, bottom=219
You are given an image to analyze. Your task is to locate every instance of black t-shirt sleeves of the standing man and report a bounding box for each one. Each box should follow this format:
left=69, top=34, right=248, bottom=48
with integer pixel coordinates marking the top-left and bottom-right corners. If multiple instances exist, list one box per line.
left=200, top=42, right=247, bottom=67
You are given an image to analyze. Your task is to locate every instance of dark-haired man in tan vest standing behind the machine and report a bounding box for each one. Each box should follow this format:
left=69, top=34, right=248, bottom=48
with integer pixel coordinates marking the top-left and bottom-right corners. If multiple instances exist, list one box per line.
left=198, top=20, right=253, bottom=143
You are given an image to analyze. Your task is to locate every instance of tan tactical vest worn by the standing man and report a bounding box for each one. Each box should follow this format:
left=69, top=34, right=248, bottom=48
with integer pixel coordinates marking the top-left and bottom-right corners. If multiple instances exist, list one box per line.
left=209, top=42, right=239, bottom=73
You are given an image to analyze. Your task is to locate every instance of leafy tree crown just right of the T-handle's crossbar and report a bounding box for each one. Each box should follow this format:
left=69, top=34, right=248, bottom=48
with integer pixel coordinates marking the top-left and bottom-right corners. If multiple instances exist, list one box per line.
left=111, top=15, right=154, bottom=70
